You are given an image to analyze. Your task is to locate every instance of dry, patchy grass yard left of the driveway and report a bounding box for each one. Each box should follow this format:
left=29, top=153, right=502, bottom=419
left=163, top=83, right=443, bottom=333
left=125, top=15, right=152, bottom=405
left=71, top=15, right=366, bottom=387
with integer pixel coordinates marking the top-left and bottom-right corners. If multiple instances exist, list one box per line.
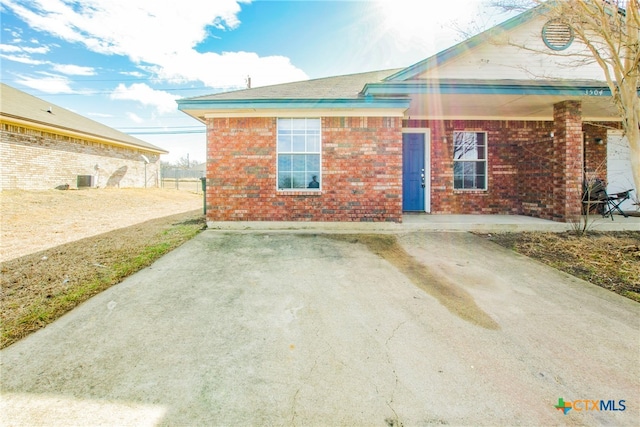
left=0, top=189, right=204, bottom=348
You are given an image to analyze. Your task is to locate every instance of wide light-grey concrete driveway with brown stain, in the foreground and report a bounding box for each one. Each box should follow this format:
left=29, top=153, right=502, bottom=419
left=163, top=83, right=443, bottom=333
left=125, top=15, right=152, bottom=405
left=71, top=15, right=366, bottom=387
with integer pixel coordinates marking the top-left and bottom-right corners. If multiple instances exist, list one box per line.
left=0, top=231, right=640, bottom=426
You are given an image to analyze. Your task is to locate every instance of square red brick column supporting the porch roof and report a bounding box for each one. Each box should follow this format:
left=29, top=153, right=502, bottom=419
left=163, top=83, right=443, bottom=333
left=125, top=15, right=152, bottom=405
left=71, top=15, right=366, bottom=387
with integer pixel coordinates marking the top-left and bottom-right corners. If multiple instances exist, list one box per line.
left=553, top=101, right=583, bottom=222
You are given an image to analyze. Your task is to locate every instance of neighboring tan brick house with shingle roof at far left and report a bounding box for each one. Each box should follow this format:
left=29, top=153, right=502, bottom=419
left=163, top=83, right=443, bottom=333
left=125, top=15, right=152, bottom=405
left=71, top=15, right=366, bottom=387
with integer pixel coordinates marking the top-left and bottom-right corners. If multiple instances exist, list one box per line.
left=0, top=84, right=167, bottom=190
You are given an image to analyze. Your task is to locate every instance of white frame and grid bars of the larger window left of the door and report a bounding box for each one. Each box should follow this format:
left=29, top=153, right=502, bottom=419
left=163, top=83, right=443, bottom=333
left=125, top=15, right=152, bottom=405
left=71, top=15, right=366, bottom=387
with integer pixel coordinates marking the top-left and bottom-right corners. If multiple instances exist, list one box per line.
left=276, top=117, right=322, bottom=193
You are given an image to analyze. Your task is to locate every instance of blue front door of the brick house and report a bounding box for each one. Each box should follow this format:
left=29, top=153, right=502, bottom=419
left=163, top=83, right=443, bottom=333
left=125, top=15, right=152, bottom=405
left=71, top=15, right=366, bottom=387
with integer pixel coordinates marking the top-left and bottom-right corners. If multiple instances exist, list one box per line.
left=402, top=133, right=426, bottom=212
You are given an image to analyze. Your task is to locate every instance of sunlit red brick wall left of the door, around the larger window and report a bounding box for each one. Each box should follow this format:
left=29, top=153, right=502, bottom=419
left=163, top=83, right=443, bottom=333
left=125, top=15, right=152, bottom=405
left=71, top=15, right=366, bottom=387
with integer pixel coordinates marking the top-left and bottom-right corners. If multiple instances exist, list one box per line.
left=207, top=117, right=402, bottom=222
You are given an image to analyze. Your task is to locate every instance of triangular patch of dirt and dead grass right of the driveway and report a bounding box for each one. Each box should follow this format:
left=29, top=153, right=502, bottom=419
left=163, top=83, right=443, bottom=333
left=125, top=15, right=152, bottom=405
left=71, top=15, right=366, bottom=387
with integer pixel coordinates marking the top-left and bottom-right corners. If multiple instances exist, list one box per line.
left=484, top=231, right=640, bottom=302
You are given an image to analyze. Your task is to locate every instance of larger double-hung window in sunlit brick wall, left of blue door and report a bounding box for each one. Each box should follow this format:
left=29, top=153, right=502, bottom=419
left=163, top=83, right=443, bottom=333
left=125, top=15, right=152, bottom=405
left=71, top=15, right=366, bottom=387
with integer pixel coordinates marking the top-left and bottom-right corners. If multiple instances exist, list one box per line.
left=278, top=118, right=322, bottom=191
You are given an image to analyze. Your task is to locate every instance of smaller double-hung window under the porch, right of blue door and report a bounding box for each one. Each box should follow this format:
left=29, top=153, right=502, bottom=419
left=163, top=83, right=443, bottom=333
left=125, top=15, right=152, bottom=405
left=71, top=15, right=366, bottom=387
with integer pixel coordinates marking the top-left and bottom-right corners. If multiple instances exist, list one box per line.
left=453, top=132, right=487, bottom=190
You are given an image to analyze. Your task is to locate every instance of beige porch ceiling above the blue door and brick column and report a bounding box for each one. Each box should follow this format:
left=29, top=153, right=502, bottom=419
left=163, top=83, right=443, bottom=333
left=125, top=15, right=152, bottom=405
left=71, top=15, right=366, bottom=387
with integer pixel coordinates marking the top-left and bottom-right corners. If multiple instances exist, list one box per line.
left=406, top=94, right=619, bottom=121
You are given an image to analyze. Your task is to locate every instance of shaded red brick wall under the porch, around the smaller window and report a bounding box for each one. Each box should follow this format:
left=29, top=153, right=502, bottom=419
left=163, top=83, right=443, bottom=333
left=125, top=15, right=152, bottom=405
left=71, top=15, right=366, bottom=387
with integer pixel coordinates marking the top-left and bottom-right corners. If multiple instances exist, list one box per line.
left=404, top=117, right=606, bottom=220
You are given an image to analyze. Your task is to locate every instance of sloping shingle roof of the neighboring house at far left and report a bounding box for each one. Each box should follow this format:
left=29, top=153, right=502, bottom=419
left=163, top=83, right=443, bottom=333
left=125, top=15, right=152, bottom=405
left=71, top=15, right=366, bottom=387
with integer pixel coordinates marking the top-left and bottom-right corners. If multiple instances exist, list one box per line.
left=0, top=83, right=167, bottom=153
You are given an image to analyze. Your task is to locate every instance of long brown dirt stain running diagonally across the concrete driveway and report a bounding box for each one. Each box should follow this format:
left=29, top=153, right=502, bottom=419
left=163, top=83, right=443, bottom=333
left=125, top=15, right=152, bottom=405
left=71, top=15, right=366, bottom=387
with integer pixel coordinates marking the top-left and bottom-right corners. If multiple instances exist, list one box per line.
left=322, top=234, right=500, bottom=329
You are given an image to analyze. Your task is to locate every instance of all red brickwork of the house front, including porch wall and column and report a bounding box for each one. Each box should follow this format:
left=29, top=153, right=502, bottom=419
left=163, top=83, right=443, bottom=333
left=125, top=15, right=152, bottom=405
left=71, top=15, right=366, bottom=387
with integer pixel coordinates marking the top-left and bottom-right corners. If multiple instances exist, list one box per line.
left=207, top=116, right=606, bottom=222
